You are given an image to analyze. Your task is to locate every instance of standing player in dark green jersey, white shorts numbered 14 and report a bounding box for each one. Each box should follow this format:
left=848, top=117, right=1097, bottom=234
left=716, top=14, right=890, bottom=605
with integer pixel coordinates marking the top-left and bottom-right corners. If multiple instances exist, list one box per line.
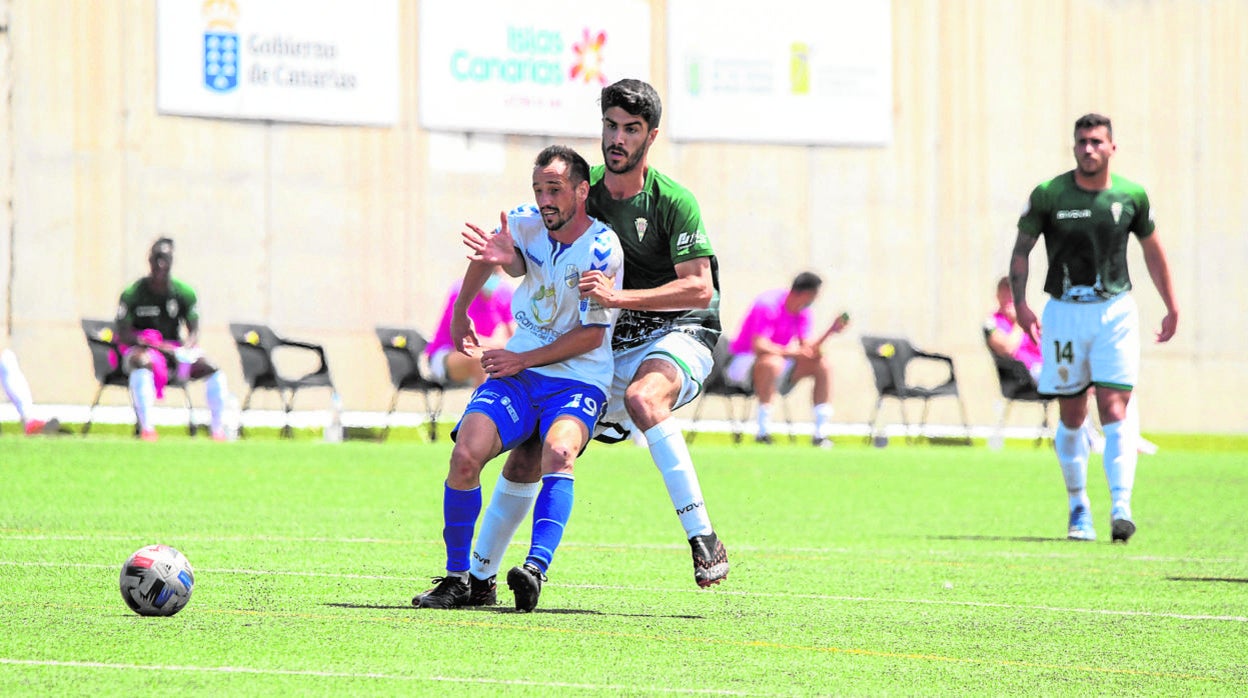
left=1010, top=114, right=1178, bottom=543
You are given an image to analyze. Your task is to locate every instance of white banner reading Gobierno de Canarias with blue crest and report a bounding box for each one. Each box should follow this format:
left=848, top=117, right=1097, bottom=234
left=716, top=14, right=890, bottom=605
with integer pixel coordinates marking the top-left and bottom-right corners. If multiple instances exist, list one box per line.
left=156, top=0, right=398, bottom=126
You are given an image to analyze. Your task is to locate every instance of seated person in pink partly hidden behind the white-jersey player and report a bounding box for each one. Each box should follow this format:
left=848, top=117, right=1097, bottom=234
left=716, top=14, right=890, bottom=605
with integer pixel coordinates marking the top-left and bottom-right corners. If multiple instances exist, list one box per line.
left=424, top=272, right=515, bottom=387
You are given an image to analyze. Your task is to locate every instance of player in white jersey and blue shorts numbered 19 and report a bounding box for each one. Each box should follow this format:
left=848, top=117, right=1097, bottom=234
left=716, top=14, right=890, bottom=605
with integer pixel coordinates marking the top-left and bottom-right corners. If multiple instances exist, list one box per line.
left=412, top=146, right=624, bottom=611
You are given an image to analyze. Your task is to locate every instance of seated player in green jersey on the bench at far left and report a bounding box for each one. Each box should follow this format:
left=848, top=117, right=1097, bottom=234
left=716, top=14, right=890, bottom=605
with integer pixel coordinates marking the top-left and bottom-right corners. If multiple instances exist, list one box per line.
left=117, top=237, right=228, bottom=441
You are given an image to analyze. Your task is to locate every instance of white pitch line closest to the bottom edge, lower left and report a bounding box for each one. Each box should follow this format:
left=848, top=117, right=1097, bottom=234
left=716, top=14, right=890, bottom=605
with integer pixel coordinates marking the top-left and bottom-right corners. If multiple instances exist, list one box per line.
left=0, top=657, right=769, bottom=696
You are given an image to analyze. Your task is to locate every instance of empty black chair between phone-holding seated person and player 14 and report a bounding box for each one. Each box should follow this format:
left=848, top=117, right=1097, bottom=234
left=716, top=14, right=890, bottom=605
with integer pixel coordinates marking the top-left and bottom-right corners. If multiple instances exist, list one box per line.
left=862, top=336, right=971, bottom=443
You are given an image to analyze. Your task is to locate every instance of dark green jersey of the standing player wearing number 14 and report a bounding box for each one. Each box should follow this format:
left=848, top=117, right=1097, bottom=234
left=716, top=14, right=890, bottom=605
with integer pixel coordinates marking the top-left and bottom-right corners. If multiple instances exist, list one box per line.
left=1018, top=170, right=1154, bottom=301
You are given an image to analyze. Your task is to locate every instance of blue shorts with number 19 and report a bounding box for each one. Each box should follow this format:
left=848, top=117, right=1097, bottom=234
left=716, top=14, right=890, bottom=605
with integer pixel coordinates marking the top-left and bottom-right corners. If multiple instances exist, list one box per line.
left=451, top=371, right=607, bottom=451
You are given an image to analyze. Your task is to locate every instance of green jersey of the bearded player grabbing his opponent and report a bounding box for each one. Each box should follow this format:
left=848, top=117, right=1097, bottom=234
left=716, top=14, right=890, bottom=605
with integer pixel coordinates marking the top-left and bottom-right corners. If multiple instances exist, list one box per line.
left=587, top=165, right=720, bottom=351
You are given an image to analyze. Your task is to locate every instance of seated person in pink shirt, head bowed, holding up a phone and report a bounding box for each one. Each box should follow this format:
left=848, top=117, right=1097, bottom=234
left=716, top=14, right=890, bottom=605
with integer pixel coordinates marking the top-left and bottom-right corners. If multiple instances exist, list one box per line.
left=725, top=271, right=849, bottom=448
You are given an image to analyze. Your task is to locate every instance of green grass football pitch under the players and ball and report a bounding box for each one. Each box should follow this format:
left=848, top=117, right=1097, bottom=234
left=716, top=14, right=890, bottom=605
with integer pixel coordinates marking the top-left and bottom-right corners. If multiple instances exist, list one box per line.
left=0, top=430, right=1248, bottom=696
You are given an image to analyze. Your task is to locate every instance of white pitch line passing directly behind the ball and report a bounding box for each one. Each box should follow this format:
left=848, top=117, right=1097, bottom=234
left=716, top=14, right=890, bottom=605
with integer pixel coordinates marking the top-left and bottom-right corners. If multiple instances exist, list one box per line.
left=0, top=559, right=1248, bottom=623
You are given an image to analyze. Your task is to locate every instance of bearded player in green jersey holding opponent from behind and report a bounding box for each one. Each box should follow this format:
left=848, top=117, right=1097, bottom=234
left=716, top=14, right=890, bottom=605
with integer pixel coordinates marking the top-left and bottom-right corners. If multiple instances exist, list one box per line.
left=456, top=80, right=729, bottom=587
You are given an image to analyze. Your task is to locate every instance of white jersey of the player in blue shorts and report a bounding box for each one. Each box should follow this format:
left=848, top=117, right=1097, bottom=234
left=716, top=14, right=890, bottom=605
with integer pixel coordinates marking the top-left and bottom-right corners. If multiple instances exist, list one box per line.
left=507, top=205, right=624, bottom=393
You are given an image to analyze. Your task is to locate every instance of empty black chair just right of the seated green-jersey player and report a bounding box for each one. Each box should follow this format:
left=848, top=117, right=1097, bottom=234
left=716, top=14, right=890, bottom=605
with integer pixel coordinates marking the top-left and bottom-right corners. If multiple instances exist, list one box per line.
left=230, top=322, right=336, bottom=438
